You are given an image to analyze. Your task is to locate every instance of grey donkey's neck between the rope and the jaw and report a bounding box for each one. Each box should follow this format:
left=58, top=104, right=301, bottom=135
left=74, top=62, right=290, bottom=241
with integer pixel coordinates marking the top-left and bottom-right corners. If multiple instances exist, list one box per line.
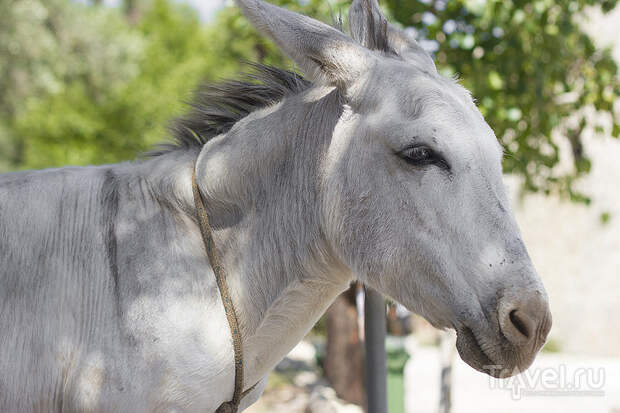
left=188, top=88, right=352, bottom=385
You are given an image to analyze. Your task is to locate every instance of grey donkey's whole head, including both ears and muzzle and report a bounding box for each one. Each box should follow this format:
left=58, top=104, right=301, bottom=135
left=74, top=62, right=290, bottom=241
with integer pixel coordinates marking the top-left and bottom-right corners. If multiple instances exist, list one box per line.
left=237, top=0, right=551, bottom=376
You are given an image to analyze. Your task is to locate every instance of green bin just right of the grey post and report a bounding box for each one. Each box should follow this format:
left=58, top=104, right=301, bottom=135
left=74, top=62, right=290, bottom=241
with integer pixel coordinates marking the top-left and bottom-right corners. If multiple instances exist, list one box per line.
left=385, top=336, right=410, bottom=413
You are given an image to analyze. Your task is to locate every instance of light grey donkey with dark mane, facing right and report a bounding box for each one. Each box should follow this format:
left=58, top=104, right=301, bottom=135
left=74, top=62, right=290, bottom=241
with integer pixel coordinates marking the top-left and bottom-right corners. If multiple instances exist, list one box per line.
left=0, top=0, right=551, bottom=413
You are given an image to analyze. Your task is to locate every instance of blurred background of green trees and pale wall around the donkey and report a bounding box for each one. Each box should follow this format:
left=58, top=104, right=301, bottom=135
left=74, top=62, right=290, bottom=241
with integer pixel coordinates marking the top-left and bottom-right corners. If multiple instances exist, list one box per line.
left=0, top=0, right=620, bottom=413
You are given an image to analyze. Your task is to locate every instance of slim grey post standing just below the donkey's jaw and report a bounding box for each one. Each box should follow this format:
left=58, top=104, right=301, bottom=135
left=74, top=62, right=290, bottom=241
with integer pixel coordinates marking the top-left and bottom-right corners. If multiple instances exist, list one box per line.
left=364, top=287, right=388, bottom=413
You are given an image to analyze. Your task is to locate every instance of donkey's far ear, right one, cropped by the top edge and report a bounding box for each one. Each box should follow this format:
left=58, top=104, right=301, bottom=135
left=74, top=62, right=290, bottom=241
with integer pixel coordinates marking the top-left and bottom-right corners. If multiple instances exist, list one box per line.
left=349, top=0, right=437, bottom=71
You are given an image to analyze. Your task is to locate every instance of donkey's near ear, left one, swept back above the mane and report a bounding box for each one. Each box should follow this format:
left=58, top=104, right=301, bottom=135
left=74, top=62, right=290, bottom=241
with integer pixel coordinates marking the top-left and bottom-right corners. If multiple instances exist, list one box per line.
left=235, top=0, right=373, bottom=87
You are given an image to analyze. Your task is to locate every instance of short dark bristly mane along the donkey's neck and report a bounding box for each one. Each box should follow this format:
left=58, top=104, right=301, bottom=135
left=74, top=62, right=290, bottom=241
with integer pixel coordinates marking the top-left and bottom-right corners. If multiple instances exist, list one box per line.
left=151, top=63, right=312, bottom=156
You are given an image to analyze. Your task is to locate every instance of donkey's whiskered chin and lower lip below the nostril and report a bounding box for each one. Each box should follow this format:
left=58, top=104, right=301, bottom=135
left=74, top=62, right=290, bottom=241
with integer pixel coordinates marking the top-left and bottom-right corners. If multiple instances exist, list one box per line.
left=456, top=327, right=537, bottom=378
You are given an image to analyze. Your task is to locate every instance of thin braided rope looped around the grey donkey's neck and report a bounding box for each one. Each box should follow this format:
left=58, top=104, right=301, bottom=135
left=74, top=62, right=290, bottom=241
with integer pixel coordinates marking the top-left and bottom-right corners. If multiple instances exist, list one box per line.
left=192, top=165, right=258, bottom=413
